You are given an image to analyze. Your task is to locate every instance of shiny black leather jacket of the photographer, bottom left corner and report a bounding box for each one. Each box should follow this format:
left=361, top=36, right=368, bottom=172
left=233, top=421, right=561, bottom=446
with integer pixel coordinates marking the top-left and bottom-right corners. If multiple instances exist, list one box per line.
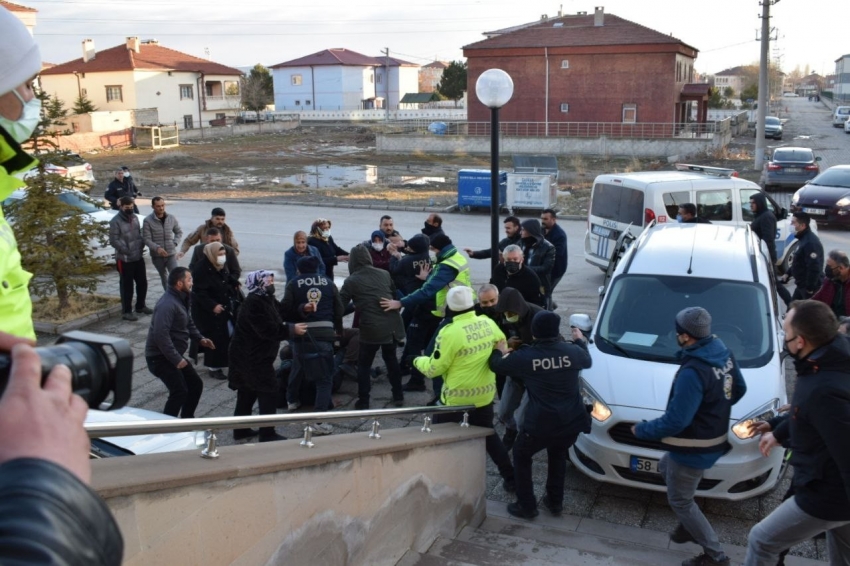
left=0, top=458, right=124, bottom=566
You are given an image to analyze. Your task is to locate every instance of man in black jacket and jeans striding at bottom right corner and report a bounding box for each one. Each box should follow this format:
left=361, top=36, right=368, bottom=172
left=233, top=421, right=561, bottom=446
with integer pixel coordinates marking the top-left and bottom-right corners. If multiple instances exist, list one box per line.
left=745, top=301, right=850, bottom=566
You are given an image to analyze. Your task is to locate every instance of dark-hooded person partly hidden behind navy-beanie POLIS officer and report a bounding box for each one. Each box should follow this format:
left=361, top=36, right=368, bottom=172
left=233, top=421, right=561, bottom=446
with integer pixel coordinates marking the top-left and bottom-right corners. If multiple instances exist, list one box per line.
left=496, top=287, right=543, bottom=450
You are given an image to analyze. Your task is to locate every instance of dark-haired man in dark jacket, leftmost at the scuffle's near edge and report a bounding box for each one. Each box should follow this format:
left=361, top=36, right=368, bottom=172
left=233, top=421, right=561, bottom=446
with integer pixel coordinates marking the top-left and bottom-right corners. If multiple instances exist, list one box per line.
left=145, top=267, right=215, bottom=419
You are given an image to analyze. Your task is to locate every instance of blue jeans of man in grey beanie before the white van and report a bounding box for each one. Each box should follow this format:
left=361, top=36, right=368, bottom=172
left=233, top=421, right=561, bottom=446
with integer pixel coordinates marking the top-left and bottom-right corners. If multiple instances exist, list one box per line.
left=658, top=452, right=726, bottom=561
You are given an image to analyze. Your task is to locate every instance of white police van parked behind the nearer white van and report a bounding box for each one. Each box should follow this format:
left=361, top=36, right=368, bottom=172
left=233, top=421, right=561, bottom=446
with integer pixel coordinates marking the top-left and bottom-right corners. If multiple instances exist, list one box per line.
left=584, top=164, right=800, bottom=272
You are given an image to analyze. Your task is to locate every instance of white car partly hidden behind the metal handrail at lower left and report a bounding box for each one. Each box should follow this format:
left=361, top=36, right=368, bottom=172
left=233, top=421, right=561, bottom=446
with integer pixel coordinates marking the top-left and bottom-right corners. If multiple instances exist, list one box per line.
left=86, top=407, right=204, bottom=459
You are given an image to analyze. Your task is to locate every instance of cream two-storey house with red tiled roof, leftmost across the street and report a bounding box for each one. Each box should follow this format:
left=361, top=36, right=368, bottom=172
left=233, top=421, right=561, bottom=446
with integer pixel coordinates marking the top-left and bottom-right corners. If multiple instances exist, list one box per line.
left=41, top=37, right=242, bottom=128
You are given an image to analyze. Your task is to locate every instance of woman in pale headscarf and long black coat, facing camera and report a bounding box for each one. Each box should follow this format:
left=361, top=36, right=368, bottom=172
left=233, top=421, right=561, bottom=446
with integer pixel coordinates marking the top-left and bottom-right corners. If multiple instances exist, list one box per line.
left=187, top=242, right=237, bottom=379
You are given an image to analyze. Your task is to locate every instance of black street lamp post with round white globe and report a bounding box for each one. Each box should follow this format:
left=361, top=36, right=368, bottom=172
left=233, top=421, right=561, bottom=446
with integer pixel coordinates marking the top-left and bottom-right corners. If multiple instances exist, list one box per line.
left=475, top=69, right=514, bottom=274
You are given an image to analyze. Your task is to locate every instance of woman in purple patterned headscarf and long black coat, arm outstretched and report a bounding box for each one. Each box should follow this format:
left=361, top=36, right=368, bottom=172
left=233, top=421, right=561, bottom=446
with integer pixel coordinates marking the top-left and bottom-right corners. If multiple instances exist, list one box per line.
left=228, top=269, right=307, bottom=442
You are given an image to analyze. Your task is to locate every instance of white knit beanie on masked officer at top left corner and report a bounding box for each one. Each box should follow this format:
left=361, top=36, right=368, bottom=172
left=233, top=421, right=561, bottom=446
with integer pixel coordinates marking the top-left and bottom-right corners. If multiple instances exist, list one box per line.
left=0, top=8, right=41, bottom=94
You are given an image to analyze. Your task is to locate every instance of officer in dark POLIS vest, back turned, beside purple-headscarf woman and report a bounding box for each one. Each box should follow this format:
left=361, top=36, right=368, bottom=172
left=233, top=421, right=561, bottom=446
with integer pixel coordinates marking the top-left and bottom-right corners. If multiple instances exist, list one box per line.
left=281, top=256, right=345, bottom=434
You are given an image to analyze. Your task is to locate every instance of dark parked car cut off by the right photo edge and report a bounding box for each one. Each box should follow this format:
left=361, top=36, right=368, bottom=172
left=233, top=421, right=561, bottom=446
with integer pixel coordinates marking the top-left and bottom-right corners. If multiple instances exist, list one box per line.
left=791, top=165, right=850, bottom=226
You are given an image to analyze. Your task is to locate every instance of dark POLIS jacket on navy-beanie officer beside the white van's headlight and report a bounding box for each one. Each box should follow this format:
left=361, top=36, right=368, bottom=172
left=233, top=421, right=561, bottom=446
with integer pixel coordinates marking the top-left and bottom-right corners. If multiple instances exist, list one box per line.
left=490, top=338, right=592, bottom=437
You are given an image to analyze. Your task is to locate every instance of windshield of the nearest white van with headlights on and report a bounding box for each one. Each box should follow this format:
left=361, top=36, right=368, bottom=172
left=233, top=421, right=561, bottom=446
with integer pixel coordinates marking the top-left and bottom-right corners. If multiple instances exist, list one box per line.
left=595, top=275, right=774, bottom=368
